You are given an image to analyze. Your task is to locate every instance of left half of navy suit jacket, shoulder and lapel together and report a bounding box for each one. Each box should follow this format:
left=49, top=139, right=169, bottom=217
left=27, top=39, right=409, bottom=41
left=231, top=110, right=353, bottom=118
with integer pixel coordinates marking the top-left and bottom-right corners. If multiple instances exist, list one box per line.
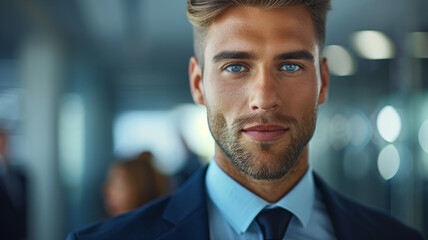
left=68, top=168, right=209, bottom=240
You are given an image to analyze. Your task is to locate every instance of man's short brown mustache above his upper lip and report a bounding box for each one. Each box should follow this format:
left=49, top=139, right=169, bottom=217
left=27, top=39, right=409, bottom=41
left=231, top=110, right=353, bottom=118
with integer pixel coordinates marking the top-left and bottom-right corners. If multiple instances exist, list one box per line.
left=232, top=112, right=298, bottom=131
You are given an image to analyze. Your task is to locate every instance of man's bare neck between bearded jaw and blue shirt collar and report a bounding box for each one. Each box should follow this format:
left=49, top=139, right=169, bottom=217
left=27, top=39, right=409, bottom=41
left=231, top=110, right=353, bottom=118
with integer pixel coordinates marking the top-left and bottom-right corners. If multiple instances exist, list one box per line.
left=215, top=146, right=309, bottom=203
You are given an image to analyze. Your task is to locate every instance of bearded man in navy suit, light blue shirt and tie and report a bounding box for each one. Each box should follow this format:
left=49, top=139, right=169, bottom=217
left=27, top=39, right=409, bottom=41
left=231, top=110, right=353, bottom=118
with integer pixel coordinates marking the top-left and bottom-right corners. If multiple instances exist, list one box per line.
left=69, top=0, right=422, bottom=239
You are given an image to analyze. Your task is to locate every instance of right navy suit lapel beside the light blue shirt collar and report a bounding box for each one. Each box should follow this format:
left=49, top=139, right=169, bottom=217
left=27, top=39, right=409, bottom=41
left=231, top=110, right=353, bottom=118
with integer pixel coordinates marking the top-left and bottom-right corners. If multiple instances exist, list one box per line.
left=314, top=174, right=375, bottom=240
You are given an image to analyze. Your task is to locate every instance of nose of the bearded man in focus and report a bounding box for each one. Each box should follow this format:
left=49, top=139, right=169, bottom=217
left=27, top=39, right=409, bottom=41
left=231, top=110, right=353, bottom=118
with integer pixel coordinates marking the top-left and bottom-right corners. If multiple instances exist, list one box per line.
left=249, top=70, right=281, bottom=111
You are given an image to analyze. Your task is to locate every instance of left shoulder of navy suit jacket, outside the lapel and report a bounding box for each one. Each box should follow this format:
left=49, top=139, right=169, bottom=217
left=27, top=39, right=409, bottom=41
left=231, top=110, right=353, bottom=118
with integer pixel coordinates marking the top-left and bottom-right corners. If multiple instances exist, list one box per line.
left=67, top=197, right=172, bottom=240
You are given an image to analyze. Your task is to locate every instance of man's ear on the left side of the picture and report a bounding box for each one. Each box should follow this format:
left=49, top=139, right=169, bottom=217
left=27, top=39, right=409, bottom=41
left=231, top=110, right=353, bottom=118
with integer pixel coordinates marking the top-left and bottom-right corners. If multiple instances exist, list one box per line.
left=189, top=57, right=205, bottom=105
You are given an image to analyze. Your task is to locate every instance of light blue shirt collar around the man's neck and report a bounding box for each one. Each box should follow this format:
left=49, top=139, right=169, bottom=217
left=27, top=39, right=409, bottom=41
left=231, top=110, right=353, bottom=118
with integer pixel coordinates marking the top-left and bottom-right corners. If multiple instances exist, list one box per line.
left=205, top=159, right=315, bottom=234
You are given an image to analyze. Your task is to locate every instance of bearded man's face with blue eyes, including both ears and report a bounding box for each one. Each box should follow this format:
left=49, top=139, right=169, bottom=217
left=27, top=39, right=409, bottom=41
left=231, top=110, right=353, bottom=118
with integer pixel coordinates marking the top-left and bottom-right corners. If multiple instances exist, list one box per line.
left=189, top=6, right=328, bottom=180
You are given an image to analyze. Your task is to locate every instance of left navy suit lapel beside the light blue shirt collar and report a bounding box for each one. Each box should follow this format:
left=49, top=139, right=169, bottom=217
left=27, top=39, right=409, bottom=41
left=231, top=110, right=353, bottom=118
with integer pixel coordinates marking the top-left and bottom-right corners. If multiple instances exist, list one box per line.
left=159, top=168, right=209, bottom=240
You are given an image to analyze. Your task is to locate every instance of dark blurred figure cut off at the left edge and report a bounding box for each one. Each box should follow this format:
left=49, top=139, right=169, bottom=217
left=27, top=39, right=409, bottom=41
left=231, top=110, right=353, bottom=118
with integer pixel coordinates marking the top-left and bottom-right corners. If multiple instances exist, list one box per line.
left=0, top=129, right=27, bottom=240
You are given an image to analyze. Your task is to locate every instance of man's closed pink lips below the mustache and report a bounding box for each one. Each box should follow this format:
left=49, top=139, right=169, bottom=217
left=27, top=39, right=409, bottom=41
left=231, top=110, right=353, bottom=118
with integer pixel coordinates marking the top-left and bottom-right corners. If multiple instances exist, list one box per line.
left=242, top=124, right=288, bottom=142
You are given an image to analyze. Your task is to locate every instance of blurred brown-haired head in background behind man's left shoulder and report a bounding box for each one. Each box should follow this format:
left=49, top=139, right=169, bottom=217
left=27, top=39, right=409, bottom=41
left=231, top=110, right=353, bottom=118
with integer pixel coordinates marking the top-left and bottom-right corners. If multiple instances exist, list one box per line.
left=104, top=152, right=170, bottom=217
